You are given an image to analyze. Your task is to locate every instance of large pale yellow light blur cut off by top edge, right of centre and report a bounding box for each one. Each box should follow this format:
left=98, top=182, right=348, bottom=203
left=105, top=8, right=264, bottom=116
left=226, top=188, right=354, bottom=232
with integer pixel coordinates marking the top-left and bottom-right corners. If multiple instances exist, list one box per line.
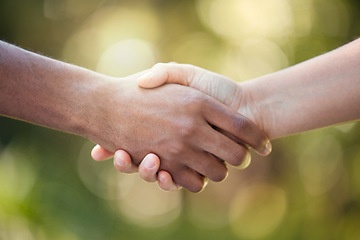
left=198, top=0, right=294, bottom=40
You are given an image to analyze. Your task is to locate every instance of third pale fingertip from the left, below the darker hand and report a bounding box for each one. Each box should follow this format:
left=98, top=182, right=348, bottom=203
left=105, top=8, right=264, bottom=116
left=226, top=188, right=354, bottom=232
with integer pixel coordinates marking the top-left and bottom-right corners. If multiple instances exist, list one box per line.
left=139, top=153, right=160, bottom=182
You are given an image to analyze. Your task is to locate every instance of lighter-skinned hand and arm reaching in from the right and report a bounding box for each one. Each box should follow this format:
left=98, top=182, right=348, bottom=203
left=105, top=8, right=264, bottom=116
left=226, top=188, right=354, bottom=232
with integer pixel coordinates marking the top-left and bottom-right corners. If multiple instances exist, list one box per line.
left=93, top=39, right=360, bottom=190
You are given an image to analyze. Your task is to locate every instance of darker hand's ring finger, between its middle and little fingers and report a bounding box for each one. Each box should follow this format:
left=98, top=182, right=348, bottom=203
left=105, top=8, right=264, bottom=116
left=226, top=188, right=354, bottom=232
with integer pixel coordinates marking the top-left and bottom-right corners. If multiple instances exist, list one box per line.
left=185, top=152, right=228, bottom=182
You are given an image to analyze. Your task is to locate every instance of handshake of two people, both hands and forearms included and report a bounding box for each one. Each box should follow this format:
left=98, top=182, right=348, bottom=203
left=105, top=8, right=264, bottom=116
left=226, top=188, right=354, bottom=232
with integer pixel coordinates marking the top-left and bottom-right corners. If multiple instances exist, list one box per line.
left=0, top=40, right=360, bottom=192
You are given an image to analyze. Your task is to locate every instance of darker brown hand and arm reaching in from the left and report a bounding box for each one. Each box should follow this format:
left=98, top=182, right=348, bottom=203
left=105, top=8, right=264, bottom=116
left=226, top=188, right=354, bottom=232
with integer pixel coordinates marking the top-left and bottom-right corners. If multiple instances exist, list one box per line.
left=0, top=41, right=269, bottom=192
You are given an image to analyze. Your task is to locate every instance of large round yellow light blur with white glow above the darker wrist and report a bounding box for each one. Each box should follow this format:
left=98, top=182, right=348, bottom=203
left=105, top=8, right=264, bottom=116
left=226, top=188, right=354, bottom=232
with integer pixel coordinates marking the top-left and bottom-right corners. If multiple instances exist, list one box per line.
left=62, top=5, right=160, bottom=70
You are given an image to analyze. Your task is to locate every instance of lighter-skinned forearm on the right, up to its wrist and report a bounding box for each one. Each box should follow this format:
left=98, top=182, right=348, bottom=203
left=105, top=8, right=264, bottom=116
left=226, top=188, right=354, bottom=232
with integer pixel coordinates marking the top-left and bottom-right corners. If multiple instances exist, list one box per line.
left=241, top=40, right=360, bottom=139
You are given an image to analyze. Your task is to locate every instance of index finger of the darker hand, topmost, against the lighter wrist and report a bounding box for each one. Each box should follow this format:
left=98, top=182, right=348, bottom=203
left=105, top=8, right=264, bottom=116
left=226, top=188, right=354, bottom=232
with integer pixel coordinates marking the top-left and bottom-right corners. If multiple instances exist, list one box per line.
left=203, top=98, right=272, bottom=155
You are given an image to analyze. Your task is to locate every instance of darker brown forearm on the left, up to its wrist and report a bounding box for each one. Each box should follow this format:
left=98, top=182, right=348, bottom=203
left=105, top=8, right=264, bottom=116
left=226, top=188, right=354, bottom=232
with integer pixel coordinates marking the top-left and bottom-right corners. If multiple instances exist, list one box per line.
left=0, top=41, right=105, bottom=138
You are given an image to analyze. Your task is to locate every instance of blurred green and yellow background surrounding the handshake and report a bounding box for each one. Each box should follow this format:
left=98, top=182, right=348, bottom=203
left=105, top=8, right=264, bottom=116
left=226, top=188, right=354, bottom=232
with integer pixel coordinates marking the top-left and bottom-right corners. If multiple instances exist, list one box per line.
left=0, top=0, right=360, bottom=240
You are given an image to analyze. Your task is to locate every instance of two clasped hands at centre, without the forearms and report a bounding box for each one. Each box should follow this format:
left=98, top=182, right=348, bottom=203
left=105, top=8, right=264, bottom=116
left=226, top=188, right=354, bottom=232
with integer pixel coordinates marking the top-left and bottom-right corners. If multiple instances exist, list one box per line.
left=92, top=63, right=271, bottom=192
